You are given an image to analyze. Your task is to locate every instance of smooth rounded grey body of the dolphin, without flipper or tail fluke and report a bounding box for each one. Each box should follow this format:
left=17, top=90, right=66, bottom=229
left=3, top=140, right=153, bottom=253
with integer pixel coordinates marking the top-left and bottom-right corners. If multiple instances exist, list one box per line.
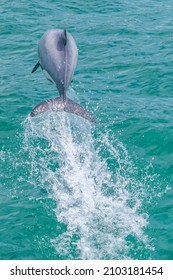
left=38, top=29, right=78, bottom=96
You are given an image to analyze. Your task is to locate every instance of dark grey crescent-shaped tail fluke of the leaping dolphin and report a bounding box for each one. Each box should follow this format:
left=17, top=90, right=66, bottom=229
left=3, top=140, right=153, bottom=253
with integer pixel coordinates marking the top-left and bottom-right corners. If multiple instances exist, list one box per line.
left=31, top=97, right=96, bottom=123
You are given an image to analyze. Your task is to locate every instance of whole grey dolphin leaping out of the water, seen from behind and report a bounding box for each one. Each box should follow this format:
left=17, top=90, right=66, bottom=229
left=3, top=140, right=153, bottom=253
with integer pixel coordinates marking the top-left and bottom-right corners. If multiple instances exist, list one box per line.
left=31, top=29, right=95, bottom=123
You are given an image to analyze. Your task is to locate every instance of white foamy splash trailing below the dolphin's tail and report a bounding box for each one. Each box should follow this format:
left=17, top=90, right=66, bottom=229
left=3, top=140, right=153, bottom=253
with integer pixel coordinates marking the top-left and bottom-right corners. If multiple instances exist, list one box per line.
left=21, top=108, right=157, bottom=259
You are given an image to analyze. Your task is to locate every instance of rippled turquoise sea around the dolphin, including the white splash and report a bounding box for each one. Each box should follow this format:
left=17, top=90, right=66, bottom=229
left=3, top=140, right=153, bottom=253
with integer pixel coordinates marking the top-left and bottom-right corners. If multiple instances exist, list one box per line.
left=0, top=0, right=173, bottom=260
